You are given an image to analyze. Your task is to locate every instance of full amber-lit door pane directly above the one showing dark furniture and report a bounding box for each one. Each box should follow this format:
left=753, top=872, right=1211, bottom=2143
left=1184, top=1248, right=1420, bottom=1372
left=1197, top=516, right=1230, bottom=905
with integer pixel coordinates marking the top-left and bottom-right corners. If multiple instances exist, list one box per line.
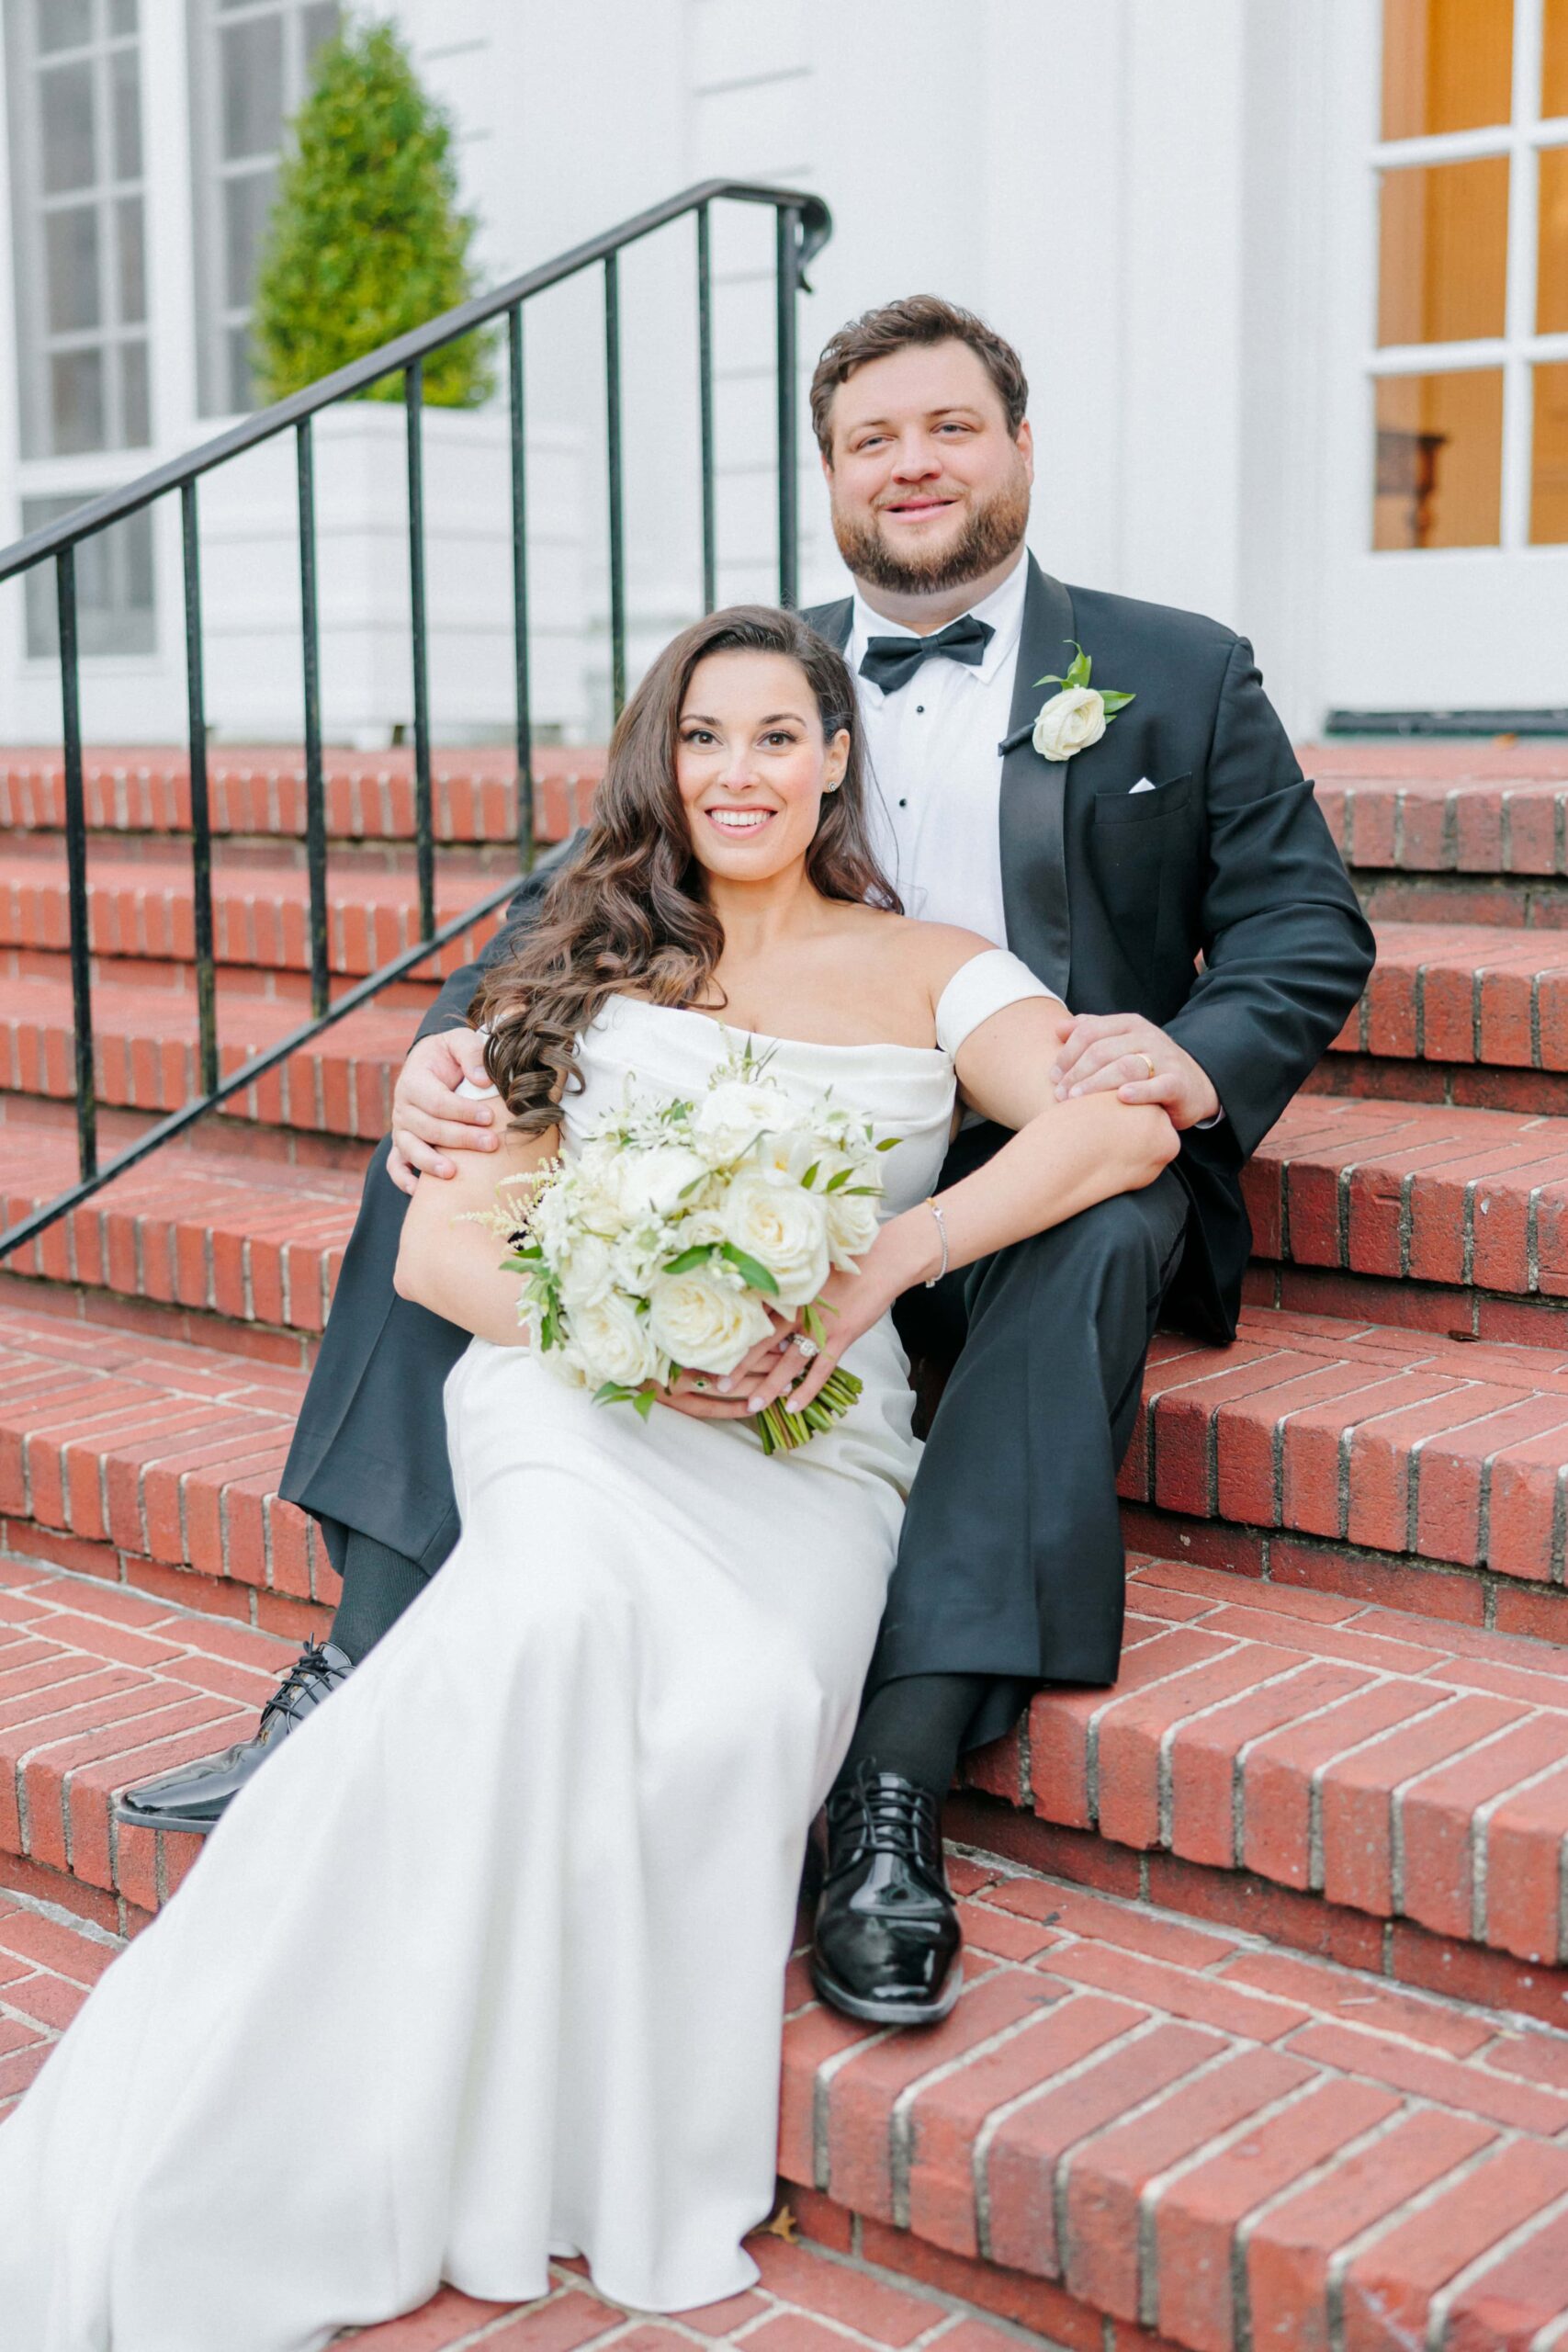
left=1378, top=155, right=1509, bottom=344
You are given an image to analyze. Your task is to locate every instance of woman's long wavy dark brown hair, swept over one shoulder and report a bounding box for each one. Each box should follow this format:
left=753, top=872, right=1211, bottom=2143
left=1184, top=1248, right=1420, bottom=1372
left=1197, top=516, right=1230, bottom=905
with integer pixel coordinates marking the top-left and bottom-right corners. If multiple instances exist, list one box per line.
left=470, top=605, right=900, bottom=1134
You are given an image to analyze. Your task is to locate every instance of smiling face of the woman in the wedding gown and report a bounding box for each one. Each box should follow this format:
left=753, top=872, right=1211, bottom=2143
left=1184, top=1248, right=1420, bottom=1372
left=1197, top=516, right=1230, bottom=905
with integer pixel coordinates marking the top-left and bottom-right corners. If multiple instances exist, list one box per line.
left=674, top=651, right=849, bottom=882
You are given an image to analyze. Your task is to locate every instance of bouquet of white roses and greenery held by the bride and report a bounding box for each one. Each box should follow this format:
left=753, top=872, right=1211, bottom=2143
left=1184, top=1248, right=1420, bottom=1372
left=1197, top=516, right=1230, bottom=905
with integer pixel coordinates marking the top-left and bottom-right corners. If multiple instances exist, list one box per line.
left=484, top=1042, right=898, bottom=1453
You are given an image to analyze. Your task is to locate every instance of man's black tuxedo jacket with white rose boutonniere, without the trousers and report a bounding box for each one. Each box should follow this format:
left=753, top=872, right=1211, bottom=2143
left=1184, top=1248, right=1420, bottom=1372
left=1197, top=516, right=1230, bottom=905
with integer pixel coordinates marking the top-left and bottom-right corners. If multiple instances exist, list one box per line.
left=421, top=558, right=1373, bottom=1340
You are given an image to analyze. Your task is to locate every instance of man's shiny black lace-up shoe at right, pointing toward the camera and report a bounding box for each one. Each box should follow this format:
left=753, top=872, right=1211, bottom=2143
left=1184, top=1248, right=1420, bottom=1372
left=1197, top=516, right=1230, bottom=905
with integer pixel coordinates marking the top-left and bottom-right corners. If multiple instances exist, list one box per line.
left=811, top=1764, right=964, bottom=2025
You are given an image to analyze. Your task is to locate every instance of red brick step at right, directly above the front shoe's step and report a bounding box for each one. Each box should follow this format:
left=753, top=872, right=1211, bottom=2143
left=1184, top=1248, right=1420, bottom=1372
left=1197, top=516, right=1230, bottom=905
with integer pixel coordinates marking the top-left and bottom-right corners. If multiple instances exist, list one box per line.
left=968, top=1559, right=1568, bottom=1975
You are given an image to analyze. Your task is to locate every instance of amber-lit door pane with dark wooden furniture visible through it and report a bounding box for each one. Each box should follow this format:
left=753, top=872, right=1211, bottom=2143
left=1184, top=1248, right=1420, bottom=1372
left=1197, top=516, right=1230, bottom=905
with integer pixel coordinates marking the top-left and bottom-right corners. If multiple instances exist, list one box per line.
left=1373, top=367, right=1502, bottom=548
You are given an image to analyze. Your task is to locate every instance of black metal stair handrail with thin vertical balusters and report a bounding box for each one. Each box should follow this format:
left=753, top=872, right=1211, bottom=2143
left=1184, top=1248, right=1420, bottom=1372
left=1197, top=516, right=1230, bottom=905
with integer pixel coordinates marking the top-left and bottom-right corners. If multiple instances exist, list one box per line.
left=0, top=179, right=832, bottom=1259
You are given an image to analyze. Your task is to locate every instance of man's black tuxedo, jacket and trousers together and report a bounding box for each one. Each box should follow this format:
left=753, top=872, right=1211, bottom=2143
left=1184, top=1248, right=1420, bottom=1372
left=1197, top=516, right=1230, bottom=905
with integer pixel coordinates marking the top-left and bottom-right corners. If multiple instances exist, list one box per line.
left=282, top=560, right=1373, bottom=1743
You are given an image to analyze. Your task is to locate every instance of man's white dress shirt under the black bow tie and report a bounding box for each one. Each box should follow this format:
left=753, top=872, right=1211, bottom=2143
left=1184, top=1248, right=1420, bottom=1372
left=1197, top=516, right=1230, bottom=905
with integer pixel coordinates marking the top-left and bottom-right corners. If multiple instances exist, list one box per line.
left=844, top=548, right=1030, bottom=948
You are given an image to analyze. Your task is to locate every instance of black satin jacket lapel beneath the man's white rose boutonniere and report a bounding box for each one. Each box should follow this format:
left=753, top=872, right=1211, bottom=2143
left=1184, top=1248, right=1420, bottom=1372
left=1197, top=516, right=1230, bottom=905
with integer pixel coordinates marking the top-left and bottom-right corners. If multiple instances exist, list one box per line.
left=999, top=555, right=1075, bottom=997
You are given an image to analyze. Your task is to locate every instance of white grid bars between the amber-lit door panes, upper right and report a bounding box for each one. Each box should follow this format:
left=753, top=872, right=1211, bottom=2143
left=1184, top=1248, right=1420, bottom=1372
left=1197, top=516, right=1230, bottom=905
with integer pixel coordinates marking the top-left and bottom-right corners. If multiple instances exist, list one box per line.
left=1363, top=0, right=1568, bottom=558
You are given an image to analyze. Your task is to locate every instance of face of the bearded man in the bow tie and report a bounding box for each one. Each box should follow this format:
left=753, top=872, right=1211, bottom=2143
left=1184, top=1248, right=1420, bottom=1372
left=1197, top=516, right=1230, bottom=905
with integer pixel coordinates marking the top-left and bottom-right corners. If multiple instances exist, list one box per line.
left=823, top=341, right=1034, bottom=595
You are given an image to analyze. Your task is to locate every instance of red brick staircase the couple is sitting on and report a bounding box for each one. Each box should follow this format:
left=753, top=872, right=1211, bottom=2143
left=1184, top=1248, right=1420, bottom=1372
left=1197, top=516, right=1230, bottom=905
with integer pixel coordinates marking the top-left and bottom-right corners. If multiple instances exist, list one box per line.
left=0, top=743, right=1568, bottom=2352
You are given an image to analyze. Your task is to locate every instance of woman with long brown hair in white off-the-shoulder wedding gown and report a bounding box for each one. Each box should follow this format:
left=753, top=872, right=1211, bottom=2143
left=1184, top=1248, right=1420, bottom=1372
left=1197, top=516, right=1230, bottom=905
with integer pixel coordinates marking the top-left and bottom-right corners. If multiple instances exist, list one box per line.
left=0, top=606, right=1176, bottom=2352
